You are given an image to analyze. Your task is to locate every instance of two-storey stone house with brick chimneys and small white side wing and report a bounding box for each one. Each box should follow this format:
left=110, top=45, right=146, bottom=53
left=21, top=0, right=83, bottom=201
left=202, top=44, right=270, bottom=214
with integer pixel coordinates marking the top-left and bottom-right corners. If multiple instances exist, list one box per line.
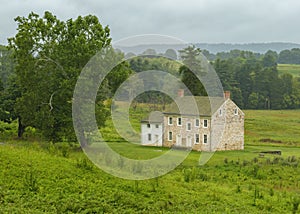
left=141, top=90, right=245, bottom=151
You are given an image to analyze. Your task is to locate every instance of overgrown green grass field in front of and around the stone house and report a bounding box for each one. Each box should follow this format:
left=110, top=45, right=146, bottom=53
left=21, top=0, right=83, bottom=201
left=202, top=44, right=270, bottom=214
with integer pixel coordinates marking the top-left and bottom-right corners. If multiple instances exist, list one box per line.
left=0, top=110, right=300, bottom=213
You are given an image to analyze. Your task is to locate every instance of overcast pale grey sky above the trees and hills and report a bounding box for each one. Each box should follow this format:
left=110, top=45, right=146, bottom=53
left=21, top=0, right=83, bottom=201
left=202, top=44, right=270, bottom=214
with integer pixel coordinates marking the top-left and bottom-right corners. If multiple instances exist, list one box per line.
left=0, top=0, right=300, bottom=44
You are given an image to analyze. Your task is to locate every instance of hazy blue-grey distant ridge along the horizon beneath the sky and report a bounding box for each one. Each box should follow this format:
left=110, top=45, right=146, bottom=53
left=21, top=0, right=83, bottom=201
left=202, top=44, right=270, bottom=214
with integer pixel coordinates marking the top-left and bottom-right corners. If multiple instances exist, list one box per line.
left=116, top=42, right=300, bottom=54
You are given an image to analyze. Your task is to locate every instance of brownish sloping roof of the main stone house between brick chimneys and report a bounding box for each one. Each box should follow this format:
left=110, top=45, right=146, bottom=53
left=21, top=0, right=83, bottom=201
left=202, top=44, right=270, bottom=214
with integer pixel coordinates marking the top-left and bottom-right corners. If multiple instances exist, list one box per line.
left=164, top=96, right=226, bottom=116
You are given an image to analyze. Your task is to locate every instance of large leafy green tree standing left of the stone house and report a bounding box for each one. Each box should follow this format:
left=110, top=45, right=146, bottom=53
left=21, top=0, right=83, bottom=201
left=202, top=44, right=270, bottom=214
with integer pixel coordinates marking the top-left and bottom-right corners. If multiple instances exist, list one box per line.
left=9, top=12, right=122, bottom=141
